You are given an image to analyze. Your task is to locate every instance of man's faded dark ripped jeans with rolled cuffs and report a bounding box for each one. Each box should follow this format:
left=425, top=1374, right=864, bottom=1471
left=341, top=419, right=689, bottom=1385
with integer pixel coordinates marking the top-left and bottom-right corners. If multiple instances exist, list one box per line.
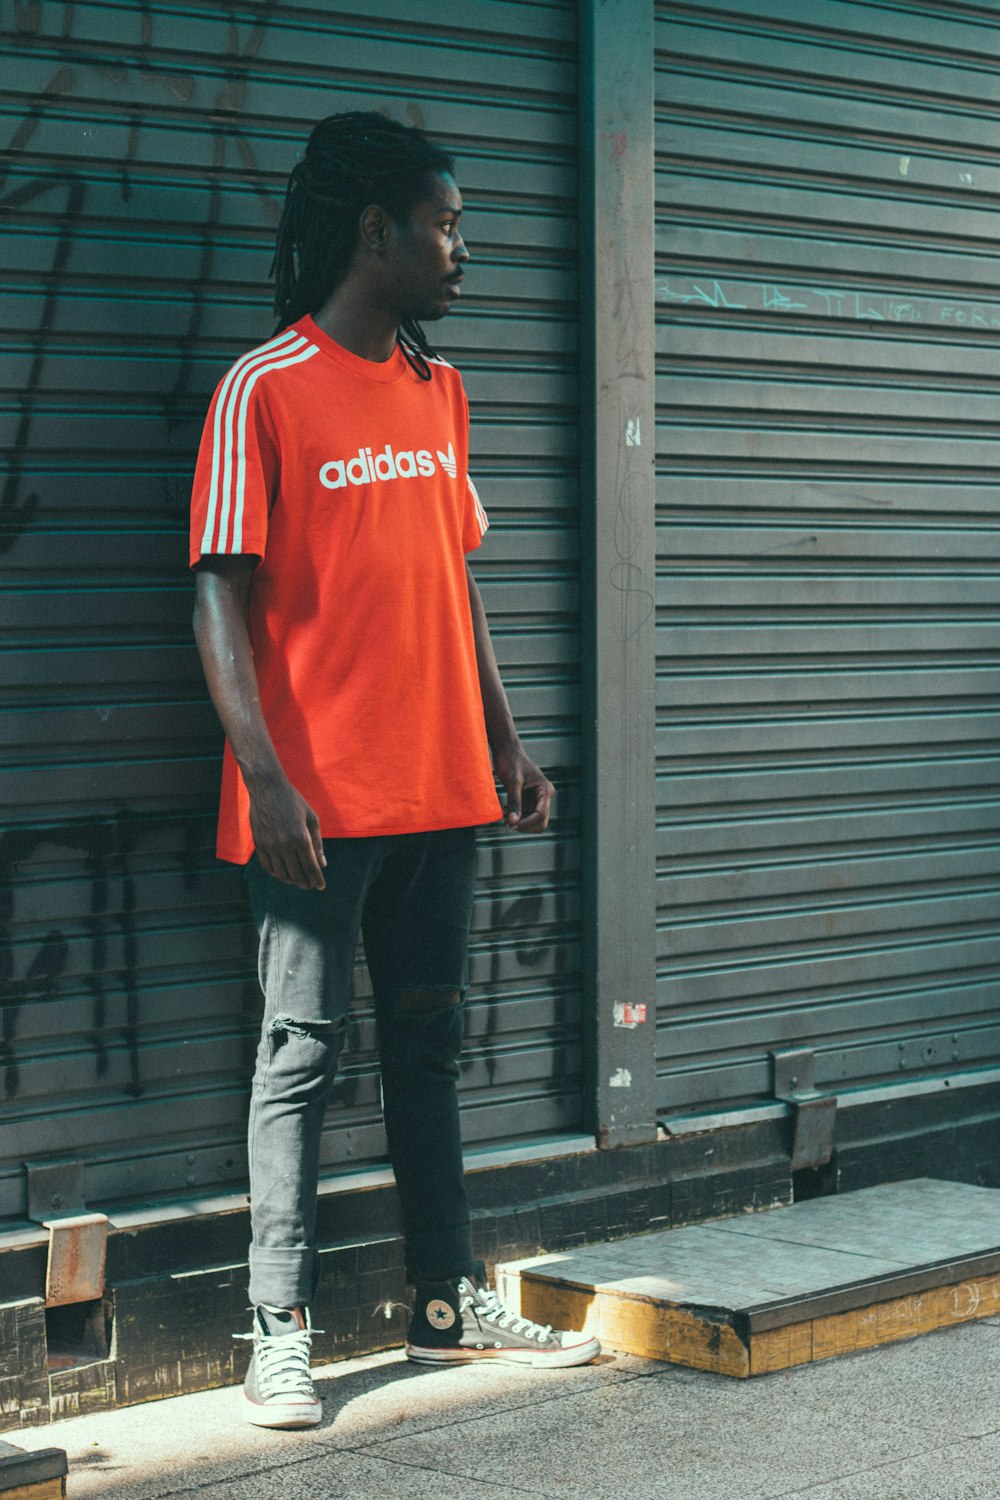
left=246, top=828, right=475, bottom=1307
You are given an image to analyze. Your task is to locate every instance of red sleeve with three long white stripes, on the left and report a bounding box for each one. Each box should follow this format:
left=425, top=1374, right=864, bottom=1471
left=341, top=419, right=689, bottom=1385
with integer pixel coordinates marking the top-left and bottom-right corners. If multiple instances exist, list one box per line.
left=190, top=356, right=277, bottom=567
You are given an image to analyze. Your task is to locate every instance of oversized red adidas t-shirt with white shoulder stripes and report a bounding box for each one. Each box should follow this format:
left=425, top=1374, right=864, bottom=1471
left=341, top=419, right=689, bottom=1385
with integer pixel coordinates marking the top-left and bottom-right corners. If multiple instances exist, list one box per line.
left=190, top=318, right=501, bottom=864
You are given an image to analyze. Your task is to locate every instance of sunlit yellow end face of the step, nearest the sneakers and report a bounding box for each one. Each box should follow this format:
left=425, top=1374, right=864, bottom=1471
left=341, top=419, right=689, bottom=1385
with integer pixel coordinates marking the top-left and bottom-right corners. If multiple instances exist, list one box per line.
left=520, top=1274, right=750, bottom=1379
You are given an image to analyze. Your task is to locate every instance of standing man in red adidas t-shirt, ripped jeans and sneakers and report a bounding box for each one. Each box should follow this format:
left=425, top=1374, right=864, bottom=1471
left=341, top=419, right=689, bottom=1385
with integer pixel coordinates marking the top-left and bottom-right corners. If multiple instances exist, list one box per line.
left=190, top=113, right=600, bottom=1427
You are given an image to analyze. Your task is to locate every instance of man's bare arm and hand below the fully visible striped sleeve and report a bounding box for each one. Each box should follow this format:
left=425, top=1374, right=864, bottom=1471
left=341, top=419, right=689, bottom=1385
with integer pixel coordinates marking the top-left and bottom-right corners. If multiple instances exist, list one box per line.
left=195, top=555, right=327, bottom=891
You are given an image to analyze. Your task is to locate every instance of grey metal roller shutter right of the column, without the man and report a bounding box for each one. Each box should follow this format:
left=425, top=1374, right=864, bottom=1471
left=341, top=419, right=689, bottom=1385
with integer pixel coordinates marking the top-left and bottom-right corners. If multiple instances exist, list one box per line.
left=657, top=0, right=1000, bottom=1113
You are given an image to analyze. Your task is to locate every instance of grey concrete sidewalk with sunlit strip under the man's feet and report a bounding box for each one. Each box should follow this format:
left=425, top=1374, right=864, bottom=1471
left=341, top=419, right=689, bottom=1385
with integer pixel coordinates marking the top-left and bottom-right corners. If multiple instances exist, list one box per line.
left=15, top=1319, right=1000, bottom=1500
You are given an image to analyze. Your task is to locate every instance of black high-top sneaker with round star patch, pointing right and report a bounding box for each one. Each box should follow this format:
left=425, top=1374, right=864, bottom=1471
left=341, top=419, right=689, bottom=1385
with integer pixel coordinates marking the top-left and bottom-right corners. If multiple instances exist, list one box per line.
left=406, top=1260, right=601, bottom=1370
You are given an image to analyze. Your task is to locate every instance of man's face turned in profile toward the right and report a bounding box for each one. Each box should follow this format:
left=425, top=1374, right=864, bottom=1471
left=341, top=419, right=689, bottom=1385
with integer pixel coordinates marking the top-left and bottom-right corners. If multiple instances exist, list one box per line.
left=385, top=174, right=469, bottom=323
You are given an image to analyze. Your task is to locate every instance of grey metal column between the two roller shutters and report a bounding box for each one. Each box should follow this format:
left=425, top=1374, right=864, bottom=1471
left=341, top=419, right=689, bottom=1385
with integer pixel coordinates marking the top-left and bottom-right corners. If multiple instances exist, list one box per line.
left=580, top=0, right=657, bottom=1146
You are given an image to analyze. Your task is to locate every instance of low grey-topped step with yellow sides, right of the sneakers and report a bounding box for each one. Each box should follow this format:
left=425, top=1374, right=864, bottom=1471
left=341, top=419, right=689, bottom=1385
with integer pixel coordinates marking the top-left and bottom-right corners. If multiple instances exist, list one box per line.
left=498, top=1178, right=1000, bottom=1377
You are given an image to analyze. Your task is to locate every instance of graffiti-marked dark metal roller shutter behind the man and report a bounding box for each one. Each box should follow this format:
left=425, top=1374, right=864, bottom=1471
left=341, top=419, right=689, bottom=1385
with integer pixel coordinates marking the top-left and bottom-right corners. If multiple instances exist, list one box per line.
left=0, top=0, right=580, bottom=1218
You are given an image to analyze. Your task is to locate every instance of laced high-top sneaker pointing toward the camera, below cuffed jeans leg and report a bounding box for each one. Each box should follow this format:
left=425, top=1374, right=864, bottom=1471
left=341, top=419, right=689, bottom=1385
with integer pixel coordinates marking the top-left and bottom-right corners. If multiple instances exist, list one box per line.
left=232, top=1305, right=322, bottom=1427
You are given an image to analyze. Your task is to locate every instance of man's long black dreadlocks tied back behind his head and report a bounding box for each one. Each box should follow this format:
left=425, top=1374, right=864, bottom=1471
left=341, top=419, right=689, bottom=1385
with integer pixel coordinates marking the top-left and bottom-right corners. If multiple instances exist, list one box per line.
left=271, top=111, right=454, bottom=380
